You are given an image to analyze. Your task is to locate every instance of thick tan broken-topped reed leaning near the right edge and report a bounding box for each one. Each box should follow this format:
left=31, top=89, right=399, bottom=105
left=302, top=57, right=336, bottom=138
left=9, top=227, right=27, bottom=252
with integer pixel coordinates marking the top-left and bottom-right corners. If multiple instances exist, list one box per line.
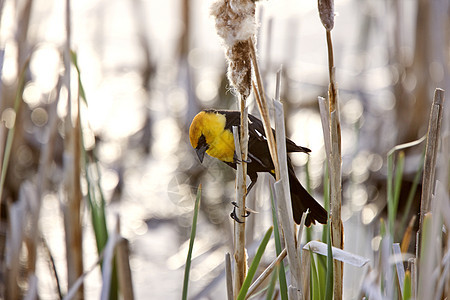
left=416, top=88, right=444, bottom=258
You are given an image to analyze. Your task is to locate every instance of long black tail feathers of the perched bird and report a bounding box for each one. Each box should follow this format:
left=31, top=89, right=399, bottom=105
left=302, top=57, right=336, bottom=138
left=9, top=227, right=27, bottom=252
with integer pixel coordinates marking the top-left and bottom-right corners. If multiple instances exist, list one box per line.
left=288, top=166, right=328, bottom=227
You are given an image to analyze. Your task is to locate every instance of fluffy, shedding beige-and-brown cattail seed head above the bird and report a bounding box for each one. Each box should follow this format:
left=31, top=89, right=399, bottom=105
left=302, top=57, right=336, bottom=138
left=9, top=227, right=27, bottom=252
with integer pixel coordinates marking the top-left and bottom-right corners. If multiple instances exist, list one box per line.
left=211, top=0, right=256, bottom=98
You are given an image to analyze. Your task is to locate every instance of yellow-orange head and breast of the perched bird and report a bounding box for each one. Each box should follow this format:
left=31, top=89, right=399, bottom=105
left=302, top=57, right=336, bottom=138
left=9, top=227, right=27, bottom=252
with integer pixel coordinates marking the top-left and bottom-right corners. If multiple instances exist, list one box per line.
left=189, top=111, right=234, bottom=162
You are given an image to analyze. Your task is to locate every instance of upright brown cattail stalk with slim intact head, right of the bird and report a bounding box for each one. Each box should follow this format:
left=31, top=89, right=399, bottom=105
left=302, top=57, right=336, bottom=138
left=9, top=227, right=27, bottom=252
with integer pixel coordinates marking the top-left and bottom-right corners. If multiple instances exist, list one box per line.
left=318, top=0, right=344, bottom=300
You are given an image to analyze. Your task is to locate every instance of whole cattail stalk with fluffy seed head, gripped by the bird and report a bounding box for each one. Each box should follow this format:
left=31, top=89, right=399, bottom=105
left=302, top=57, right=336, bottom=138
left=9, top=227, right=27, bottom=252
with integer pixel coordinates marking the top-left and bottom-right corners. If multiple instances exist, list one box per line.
left=211, top=0, right=256, bottom=297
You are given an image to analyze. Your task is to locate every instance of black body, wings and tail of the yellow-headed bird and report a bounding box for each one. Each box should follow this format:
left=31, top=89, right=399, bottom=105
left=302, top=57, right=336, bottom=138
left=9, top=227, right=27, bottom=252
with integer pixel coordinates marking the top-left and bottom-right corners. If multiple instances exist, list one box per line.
left=205, top=110, right=328, bottom=226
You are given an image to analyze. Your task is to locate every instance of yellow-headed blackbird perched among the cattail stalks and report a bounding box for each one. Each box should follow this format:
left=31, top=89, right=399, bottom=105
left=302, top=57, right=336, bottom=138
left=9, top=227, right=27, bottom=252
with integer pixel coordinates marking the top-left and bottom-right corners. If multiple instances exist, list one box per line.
left=189, top=109, right=327, bottom=226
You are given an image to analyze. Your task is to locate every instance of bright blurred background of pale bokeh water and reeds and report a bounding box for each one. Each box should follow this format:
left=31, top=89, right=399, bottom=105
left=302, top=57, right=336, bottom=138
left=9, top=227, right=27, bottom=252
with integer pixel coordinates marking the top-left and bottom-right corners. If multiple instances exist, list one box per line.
left=0, top=0, right=450, bottom=299
